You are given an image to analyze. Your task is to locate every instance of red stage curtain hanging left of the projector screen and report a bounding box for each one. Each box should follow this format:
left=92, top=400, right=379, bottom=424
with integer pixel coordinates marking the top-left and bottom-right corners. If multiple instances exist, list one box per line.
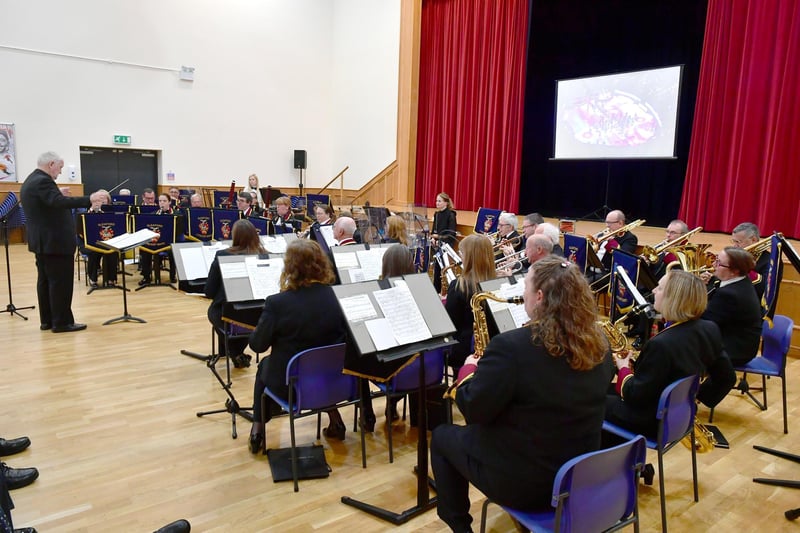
left=415, top=0, right=529, bottom=211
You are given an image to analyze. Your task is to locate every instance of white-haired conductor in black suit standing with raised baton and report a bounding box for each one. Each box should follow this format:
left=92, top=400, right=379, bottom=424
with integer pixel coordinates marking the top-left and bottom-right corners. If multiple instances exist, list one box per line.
left=20, top=152, right=100, bottom=333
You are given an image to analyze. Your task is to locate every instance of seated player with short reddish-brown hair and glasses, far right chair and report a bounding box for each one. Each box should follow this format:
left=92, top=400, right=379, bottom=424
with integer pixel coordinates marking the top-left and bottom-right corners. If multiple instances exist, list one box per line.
left=703, top=246, right=761, bottom=366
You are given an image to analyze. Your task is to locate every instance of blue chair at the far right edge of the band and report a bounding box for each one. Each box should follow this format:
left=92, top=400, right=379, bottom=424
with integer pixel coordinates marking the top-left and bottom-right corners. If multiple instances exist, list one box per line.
left=735, top=315, right=794, bottom=433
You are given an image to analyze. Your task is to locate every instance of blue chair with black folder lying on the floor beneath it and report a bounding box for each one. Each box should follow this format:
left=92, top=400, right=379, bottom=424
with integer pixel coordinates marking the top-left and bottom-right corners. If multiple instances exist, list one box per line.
left=261, top=343, right=366, bottom=492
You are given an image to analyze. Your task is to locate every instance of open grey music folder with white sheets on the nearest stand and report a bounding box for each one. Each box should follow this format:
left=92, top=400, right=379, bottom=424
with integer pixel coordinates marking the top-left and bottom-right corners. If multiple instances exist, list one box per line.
left=333, top=274, right=455, bottom=359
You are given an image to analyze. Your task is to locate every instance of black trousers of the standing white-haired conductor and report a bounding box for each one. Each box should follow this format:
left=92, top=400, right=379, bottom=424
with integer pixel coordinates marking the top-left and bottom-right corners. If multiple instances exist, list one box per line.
left=36, top=253, right=75, bottom=327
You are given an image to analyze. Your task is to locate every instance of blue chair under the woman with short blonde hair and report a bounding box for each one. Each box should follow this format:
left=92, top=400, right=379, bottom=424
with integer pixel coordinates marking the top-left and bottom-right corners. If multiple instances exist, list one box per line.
left=603, top=375, right=700, bottom=533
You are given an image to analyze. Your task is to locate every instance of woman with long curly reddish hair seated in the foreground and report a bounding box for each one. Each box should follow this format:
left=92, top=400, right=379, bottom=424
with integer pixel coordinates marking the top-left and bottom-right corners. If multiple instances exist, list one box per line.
left=431, top=256, right=613, bottom=532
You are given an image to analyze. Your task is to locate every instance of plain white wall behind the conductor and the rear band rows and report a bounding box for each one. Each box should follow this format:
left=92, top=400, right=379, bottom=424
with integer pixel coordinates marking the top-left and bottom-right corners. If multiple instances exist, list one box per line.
left=0, top=0, right=400, bottom=189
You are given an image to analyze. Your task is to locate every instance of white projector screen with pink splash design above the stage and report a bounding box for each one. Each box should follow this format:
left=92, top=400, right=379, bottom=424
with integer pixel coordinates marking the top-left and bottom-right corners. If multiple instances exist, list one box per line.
left=553, top=65, right=683, bottom=159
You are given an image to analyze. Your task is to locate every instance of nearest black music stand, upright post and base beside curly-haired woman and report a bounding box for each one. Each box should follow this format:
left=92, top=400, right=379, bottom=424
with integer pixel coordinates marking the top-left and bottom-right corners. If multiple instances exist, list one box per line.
left=333, top=273, right=457, bottom=525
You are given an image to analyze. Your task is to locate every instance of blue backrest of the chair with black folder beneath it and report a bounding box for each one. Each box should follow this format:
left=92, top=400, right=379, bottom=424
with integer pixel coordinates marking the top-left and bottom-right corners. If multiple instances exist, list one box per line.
left=286, top=343, right=358, bottom=410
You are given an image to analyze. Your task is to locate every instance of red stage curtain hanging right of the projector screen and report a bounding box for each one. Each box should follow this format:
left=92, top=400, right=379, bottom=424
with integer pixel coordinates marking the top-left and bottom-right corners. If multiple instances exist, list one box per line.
left=680, top=0, right=800, bottom=237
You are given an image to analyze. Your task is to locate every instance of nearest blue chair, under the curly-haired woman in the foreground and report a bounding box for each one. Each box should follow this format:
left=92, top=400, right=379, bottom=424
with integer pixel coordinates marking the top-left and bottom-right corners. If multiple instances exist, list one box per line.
left=481, top=435, right=647, bottom=533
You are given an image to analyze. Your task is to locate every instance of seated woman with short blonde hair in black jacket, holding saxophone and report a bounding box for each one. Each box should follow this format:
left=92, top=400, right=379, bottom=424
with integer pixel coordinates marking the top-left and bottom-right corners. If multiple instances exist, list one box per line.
left=603, top=270, right=736, bottom=448
